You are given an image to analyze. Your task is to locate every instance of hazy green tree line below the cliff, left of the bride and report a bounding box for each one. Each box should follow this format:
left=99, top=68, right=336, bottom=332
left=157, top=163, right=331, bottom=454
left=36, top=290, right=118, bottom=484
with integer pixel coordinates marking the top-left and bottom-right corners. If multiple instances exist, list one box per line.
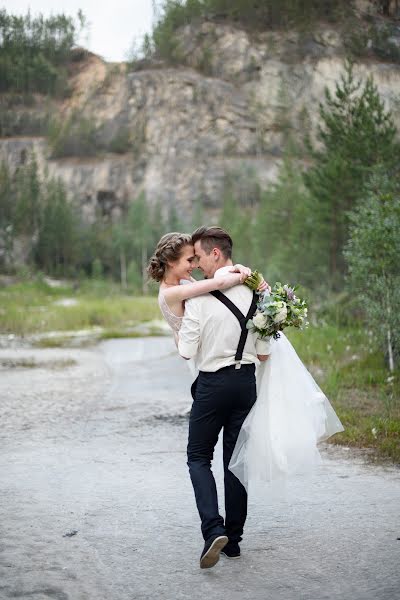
left=0, top=154, right=192, bottom=293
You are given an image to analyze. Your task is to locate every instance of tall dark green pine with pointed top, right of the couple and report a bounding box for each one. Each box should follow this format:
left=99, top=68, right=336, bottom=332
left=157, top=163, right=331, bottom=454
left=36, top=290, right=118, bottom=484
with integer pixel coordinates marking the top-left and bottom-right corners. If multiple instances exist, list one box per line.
left=305, top=64, right=400, bottom=285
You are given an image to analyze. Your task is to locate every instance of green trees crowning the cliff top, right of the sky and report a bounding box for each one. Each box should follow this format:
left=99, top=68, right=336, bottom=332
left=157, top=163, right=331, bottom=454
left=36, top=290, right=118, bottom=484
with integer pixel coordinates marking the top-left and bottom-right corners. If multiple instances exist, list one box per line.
left=138, top=0, right=400, bottom=69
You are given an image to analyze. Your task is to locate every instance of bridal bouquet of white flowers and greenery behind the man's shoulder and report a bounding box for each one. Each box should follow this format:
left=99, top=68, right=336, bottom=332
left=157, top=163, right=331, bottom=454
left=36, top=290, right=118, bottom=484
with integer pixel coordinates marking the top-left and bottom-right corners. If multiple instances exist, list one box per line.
left=244, top=271, right=308, bottom=340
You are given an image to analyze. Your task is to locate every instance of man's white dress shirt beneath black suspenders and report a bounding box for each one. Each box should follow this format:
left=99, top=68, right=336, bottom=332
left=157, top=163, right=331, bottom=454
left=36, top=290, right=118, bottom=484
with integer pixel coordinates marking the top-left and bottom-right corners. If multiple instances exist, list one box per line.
left=178, top=267, right=270, bottom=372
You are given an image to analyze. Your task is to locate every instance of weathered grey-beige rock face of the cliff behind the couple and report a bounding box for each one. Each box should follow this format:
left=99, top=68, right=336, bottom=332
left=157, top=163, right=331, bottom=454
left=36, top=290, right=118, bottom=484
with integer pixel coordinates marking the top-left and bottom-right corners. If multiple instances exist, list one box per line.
left=0, top=22, right=400, bottom=223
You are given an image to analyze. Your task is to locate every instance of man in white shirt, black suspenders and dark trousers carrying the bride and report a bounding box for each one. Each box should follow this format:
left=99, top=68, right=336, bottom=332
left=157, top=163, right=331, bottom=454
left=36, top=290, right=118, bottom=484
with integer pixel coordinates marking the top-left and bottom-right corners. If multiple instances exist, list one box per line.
left=178, top=227, right=268, bottom=569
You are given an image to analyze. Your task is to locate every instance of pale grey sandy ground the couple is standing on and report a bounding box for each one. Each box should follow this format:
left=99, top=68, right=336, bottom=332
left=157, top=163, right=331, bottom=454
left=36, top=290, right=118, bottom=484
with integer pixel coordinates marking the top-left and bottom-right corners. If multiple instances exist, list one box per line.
left=0, top=338, right=400, bottom=600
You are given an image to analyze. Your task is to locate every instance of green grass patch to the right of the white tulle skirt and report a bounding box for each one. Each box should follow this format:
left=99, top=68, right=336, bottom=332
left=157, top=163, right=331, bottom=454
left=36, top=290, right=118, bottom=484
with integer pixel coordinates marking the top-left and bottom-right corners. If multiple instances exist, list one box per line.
left=289, top=325, right=400, bottom=464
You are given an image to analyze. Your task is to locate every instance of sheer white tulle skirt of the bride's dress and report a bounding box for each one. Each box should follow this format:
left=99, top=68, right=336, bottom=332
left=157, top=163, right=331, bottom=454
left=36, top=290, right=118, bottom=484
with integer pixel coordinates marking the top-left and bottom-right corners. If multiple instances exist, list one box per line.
left=229, top=333, right=343, bottom=489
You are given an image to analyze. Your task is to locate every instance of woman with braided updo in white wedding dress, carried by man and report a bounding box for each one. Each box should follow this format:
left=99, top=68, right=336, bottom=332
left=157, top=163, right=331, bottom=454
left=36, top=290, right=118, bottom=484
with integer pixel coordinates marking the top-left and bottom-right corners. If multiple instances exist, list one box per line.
left=147, top=233, right=343, bottom=489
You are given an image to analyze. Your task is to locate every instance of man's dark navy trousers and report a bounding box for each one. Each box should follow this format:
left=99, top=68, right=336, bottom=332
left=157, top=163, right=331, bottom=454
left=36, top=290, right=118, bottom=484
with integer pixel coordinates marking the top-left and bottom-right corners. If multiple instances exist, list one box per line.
left=187, top=365, right=256, bottom=542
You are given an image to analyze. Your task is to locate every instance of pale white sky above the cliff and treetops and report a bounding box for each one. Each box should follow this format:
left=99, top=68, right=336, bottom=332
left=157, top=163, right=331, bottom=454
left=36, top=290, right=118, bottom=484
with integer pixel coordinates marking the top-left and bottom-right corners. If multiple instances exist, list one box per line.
left=0, top=0, right=153, bottom=61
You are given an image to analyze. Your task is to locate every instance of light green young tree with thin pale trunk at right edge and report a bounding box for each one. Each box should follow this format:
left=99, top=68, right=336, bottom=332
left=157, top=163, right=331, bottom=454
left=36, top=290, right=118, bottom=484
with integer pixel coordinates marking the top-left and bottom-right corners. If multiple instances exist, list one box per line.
left=345, top=169, right=400, bottom=371
